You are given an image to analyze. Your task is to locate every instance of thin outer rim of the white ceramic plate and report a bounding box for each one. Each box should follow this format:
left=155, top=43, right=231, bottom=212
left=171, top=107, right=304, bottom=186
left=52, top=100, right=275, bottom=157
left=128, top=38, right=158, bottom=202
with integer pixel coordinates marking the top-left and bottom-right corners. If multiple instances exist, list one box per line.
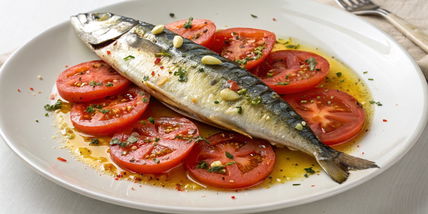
left=0, top=0, right=428, bottom=213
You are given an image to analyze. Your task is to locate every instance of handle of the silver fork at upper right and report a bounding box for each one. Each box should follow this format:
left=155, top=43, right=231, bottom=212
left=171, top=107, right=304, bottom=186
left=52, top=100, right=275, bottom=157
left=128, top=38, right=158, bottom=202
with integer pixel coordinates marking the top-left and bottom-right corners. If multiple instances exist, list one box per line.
left=382, top=13, right=428, bottom=53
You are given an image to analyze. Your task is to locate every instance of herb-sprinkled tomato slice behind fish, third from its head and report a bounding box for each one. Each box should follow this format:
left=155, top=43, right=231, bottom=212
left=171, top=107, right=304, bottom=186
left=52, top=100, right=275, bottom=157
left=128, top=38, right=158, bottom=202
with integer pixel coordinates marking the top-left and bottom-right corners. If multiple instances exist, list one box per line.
left=252, top=50, right=330, bottom=94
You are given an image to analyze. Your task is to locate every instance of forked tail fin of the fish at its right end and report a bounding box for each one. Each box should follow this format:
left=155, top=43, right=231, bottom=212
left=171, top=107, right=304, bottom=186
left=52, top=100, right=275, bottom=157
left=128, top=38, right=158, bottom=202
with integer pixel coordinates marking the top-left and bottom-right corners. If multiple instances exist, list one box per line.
left=315, top=152, right=379, bottom=184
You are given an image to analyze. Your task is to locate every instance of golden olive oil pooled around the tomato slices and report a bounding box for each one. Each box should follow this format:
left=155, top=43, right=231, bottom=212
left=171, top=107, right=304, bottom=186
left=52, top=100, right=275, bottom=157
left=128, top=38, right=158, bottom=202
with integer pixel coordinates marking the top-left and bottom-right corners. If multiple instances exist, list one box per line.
left=55, top=39, right=373, bottom=191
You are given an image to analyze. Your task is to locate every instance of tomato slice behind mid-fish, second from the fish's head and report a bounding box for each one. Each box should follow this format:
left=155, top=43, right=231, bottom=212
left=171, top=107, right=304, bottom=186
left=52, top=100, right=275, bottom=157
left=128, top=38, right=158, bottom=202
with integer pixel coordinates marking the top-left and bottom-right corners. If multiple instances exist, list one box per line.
left=210, top=28, right=276, bottom=69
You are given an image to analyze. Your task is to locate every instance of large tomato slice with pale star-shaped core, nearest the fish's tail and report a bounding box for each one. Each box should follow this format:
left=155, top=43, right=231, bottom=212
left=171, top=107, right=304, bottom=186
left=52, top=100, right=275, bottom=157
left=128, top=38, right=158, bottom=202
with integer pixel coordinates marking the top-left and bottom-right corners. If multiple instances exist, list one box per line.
left=283, top=88, right=366, bottom=145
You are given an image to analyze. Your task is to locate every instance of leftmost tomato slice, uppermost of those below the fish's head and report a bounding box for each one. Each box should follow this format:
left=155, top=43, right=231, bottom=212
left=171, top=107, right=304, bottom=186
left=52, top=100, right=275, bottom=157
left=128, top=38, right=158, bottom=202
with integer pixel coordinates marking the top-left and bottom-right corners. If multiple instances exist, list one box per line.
left=56, top=60, right=130, bottom=102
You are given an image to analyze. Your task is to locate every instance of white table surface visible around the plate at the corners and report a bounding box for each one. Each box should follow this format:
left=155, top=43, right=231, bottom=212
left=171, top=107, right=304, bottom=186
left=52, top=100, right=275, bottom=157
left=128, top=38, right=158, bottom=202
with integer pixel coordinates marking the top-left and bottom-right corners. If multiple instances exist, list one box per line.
left=0, top=0, right=428, bottom=214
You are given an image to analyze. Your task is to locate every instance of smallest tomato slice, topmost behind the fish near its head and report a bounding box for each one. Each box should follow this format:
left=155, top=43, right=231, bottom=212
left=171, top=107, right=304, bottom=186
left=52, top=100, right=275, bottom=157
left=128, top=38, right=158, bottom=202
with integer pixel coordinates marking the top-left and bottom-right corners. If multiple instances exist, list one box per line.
left=165, top=18, right=216, bottom=46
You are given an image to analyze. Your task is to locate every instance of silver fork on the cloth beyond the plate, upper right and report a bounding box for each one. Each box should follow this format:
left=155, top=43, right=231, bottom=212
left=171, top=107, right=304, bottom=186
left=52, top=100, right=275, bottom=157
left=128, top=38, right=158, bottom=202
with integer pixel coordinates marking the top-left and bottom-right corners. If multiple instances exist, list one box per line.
left=336, top=0, right=428, bottom=53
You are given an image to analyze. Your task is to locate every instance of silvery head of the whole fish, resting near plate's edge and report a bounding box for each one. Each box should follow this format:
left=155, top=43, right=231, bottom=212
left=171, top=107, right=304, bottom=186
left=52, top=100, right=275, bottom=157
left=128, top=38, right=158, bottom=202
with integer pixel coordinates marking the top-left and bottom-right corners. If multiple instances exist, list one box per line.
left=70, top=13, right=138, bottom=45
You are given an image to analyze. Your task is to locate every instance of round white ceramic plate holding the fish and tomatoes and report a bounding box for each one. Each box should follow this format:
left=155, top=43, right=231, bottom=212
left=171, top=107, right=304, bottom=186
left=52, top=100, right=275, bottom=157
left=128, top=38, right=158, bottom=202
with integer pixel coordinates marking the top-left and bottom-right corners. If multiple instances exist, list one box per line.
left=0, top=0, right=427, bottom=213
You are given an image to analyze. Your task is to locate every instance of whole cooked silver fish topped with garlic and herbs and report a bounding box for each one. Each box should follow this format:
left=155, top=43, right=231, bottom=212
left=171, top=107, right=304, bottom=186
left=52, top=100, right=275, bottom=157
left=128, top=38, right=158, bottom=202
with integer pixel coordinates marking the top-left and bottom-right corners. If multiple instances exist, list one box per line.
left=71, top=13, right=378, bottom=183
